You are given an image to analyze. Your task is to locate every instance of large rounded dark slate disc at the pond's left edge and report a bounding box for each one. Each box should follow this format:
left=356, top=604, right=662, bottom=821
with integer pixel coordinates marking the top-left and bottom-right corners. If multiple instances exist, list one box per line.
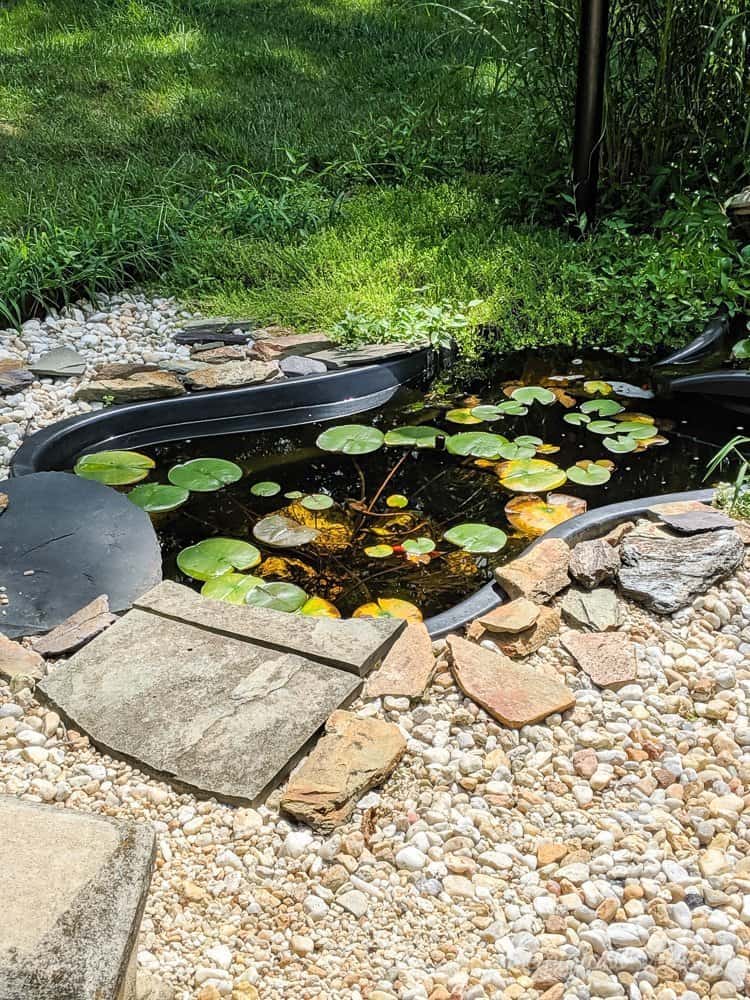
left=0, top=472, right=161, bottom=638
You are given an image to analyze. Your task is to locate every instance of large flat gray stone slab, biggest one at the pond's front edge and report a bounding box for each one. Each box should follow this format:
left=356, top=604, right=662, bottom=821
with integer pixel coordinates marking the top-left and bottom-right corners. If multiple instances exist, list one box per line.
left=37, top=610, right=361, bottom=805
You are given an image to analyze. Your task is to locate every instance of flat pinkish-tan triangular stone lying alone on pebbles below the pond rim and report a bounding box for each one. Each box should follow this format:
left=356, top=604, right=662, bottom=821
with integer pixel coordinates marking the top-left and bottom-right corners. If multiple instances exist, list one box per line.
left=448, top=635, right=575, bottom=729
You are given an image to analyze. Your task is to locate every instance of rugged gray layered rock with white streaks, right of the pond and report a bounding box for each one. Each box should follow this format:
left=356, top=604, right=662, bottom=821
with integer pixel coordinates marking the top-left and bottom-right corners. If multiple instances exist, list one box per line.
left=616, top=522, right=745, bottom=615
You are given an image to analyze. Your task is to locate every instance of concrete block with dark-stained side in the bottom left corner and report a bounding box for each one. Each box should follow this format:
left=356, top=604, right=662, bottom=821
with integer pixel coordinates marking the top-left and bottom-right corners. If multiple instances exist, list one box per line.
left=0, top=796, right=155, bottom=1000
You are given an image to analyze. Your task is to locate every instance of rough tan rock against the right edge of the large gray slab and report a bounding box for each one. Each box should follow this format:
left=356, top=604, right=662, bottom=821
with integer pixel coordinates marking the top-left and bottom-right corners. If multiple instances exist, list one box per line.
left=281, top=712, right=406, bottom=833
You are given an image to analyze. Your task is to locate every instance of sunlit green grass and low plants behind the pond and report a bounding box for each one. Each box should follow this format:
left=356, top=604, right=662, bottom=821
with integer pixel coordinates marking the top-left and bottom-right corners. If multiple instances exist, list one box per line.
left=0, top=0, right=746, bottom=349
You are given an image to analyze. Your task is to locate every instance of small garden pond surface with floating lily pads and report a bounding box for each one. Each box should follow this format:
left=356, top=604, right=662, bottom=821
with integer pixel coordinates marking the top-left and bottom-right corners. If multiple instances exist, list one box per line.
left=76, top=351, right=748, bottom=619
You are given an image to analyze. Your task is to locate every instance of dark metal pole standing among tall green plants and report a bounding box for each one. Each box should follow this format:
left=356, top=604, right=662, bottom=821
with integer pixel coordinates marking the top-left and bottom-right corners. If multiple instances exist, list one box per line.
left=573, top=0, right=609, bottom=224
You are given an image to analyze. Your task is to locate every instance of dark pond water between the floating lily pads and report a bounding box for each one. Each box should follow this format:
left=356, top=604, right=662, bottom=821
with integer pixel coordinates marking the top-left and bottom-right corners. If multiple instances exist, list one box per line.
left=82, top=350, right=737, bottom=618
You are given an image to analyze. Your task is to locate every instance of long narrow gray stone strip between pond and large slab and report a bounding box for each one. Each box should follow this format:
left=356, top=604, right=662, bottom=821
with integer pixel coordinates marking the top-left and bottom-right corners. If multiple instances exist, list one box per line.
left=135, top=580, right=405, bottom=677
